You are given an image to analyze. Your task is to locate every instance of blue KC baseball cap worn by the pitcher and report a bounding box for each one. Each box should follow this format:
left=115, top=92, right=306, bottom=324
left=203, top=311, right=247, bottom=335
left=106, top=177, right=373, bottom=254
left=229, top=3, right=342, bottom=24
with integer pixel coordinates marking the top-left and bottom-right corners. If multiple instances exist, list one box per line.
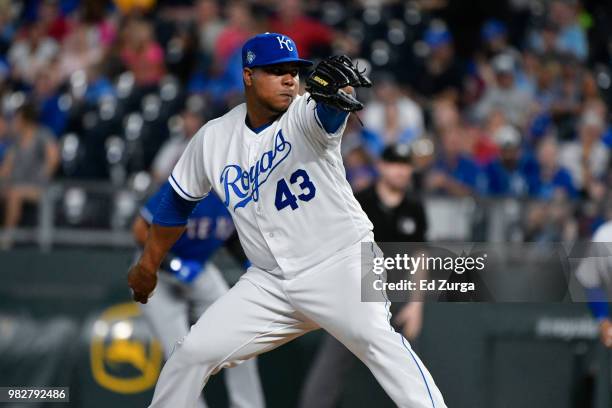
left=242, top=33, right=312, bottom=68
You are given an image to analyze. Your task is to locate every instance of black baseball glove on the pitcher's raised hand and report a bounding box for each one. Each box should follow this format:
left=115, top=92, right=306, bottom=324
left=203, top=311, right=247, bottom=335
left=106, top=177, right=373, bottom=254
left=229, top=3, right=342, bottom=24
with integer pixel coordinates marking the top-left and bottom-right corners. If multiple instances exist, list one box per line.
left=306, top=55, right=372, bottom=112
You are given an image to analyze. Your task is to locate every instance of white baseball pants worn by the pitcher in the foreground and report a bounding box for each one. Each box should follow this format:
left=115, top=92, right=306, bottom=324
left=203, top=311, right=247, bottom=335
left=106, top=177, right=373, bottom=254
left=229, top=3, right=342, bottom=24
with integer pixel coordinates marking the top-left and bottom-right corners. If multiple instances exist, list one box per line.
left=150, top=239, right=446, bottom=408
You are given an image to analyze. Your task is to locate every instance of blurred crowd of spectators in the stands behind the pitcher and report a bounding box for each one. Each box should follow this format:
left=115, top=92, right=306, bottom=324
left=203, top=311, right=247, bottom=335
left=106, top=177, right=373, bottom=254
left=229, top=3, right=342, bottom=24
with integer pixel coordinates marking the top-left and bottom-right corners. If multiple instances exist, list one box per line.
left=0, top=0, right=612, bottom=245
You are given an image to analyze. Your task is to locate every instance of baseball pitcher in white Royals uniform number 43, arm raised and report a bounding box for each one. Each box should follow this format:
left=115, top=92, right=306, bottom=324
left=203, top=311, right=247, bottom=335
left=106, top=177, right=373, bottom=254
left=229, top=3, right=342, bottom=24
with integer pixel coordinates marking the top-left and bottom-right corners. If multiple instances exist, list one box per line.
left=128, top=33, right=446, bottom=408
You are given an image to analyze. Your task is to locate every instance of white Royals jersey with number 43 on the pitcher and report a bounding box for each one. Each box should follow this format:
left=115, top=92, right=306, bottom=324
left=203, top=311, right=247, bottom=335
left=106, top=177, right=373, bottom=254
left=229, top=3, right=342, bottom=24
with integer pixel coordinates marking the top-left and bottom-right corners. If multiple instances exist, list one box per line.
left=169, top=94, right=373, bottom=274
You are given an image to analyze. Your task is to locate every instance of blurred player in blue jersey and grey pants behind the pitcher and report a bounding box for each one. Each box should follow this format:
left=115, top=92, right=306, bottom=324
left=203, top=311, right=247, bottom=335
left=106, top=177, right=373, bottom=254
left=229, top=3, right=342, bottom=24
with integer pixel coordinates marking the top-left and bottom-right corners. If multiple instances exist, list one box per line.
left=132, top=183, right=264, bottom=408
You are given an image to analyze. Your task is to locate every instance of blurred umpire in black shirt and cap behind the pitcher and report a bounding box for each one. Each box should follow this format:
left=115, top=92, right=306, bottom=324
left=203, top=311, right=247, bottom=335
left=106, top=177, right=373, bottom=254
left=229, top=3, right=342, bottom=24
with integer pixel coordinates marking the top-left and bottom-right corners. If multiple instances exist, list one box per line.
left=298, top=144, right=427, bottom=408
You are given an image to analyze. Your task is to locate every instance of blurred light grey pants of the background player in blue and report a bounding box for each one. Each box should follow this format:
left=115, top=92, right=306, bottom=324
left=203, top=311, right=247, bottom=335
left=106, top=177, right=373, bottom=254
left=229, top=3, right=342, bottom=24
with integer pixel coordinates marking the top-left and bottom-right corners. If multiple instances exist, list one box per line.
left=140, top=262, right=265, bottom=408
